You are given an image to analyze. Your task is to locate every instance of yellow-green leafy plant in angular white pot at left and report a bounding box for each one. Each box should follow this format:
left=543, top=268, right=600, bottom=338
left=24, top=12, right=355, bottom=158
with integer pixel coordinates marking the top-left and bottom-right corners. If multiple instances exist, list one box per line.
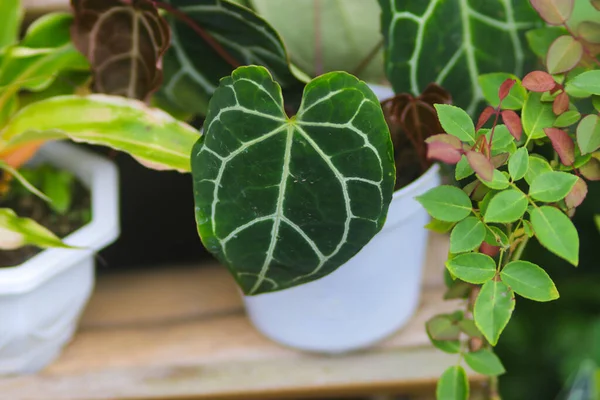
left=0, top=2, right=198, bottom=374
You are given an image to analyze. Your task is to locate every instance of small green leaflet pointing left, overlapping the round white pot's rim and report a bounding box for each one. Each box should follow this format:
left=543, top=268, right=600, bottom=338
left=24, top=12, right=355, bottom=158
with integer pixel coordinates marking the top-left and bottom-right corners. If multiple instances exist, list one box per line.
left=416, top=185, right=472, bottom=222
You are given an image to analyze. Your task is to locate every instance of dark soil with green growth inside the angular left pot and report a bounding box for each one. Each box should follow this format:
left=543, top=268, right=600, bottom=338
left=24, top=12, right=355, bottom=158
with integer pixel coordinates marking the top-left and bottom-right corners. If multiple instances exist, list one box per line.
left=0, top=165, right=91, bottom=268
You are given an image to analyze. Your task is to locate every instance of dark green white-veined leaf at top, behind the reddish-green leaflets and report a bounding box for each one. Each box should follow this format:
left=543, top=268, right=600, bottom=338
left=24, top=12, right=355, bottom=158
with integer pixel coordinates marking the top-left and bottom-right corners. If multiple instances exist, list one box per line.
left=379, top=0, right=539, bottom=114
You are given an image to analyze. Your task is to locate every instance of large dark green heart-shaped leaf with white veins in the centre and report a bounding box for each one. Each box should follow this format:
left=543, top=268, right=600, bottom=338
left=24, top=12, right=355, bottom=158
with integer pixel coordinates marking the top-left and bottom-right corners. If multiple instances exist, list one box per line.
left=192, top=66, right=396, bottom=295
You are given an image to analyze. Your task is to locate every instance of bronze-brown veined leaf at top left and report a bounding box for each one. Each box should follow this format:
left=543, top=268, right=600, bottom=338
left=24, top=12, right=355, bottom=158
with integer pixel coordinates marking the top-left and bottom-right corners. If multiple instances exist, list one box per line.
left=71, top=0, right=170, bottom=100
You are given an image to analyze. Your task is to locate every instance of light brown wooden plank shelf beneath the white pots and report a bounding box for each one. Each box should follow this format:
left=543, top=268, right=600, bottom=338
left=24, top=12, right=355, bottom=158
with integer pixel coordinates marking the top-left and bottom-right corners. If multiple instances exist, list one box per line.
left=0, top=235, right=482, bottom=400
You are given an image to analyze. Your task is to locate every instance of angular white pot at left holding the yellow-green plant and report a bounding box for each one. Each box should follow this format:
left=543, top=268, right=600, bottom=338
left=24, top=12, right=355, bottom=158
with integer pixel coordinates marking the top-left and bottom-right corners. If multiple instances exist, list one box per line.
left=0, top=143, right=119, bottom=375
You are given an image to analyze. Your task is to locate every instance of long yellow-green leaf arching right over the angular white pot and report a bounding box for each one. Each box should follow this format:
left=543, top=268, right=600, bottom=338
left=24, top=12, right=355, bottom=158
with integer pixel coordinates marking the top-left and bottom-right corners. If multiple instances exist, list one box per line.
left=0, top=94, right=199, bottom=171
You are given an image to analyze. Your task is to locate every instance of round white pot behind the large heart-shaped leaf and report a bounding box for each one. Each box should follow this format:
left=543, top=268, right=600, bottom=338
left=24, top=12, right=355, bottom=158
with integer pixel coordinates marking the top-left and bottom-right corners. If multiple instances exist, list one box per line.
left=244, top=87, right=440, bottom=353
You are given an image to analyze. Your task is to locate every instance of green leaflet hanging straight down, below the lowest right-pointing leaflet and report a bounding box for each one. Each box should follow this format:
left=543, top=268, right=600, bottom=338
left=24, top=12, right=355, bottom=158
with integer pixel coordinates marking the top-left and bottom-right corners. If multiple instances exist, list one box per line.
left=473, top=280, right=515, bottom=346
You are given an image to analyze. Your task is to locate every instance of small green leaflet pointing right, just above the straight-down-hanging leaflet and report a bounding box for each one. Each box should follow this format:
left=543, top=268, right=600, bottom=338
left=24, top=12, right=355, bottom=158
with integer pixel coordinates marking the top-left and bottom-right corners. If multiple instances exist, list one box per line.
left=500, top=261, right=558, bottom=301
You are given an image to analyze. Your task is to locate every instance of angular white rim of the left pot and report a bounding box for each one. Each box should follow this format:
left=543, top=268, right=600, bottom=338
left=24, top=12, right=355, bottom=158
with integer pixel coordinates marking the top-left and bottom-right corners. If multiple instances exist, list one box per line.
left=0, top=142, right=119, bottom=294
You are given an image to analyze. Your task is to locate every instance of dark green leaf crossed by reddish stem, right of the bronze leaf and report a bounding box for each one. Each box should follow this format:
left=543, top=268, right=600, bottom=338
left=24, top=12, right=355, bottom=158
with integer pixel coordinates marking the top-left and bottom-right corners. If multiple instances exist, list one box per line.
left=156, top=0, right=301, bottom=115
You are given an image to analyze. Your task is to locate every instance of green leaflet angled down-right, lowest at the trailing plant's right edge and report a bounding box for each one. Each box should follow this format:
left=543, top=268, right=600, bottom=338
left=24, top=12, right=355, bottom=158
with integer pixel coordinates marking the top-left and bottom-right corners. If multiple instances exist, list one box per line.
left=531, top=206, right=579, bottom=266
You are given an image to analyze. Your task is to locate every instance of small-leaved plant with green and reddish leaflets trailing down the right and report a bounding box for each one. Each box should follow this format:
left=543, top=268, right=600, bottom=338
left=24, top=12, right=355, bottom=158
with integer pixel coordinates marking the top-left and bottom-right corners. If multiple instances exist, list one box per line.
left=419, top=1, right=600, bottom=399
